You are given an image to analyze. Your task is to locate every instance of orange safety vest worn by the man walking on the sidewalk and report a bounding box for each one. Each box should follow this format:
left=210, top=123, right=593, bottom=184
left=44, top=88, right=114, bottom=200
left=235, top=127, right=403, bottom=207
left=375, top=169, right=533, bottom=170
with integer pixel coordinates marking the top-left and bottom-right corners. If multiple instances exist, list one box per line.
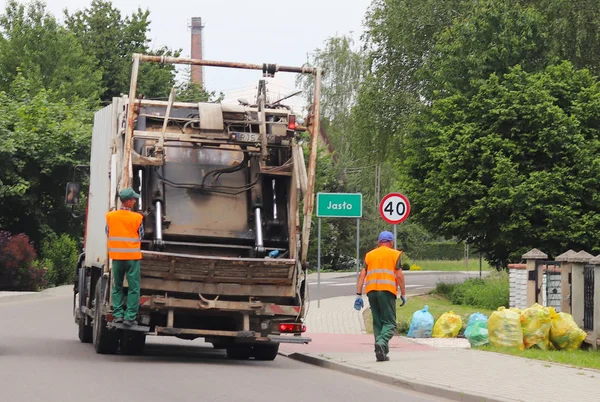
left=365, top=246, right=402, bottom=296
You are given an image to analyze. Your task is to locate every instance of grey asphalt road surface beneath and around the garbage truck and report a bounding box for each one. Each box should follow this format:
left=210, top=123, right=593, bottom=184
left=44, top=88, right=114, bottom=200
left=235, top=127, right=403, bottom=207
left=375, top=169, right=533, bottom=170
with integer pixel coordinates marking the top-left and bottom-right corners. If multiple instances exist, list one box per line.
left=0, top=288, right=448, bottom=402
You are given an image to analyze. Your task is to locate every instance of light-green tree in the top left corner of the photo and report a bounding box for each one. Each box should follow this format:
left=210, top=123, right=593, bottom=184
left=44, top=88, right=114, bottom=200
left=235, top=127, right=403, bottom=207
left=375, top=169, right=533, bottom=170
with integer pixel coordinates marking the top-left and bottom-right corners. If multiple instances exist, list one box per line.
left=0, top=0, right=100, bottom=103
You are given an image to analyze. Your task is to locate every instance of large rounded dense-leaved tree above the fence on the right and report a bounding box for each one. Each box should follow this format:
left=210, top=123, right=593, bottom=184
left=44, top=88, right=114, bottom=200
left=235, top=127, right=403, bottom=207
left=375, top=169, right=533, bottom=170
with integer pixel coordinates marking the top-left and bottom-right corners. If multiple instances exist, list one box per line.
left=405, top=62, right=600, bottom=265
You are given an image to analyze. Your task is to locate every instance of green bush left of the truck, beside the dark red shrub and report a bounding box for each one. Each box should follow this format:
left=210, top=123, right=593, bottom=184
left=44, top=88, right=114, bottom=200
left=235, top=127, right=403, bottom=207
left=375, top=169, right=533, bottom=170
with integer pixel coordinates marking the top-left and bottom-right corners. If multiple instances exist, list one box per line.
left=41, top=234, right=78, bottom=286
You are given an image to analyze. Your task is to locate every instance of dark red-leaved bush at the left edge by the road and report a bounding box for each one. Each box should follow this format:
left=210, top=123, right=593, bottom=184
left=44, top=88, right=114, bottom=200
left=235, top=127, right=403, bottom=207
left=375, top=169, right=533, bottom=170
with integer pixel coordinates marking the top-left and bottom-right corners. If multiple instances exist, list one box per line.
left=0, top=231, right=46, bottom=291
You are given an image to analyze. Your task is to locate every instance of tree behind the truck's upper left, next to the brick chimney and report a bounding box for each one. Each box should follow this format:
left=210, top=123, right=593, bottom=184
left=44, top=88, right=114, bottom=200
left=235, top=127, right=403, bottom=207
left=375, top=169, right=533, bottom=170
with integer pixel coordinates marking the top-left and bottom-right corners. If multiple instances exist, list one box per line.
left=65, top=0, right=181, bottom=101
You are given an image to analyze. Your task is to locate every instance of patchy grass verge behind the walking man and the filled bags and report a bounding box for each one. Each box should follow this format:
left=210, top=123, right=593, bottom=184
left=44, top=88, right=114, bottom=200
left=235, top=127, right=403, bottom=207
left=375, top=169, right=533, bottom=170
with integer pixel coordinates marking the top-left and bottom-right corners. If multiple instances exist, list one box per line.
left=363, top=294, right=492, bottom=335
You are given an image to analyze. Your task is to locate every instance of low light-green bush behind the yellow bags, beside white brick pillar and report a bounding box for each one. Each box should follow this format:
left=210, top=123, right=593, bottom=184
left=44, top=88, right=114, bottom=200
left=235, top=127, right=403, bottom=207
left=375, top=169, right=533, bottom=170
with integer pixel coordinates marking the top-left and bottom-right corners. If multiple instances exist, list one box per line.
left=434, top=272, right=510, bottom=310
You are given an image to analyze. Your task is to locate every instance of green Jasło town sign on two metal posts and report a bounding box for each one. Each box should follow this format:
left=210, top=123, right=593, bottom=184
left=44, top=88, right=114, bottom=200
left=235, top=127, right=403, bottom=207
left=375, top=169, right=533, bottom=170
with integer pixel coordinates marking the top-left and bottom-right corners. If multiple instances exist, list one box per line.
left=317, top=193, right=362, bottom=308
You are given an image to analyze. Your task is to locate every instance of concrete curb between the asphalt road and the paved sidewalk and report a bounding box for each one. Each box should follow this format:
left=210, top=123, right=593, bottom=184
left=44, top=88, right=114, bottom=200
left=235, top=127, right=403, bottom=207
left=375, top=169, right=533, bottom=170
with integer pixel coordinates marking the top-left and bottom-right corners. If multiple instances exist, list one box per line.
left=279, top=352, right=506, bottom=402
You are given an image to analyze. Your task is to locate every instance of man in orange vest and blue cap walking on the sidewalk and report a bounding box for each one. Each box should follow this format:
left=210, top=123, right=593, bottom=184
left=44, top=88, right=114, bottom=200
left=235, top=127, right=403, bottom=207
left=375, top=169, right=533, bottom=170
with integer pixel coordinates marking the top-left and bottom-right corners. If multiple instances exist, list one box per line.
left=354, top=231, right=406, bottom=361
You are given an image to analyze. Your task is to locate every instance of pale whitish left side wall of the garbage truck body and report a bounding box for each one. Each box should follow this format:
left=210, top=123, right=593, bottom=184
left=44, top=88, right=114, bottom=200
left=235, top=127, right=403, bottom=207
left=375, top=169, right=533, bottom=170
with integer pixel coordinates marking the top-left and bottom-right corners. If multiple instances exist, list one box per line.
left=85, top=104, right=117, bottom=266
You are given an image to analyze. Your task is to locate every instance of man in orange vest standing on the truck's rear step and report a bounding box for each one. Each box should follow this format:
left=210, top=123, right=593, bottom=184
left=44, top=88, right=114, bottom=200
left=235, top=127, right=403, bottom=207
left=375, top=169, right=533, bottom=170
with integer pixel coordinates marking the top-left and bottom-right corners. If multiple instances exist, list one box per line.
left=106, top=188, right=144, bottom=327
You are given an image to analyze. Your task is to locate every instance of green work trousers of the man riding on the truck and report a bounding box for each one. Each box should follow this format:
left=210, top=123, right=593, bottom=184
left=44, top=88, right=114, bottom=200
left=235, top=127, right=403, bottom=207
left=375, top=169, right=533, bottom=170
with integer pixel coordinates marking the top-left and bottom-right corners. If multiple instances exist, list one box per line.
left=112, top=260, right=140, bottom=321
